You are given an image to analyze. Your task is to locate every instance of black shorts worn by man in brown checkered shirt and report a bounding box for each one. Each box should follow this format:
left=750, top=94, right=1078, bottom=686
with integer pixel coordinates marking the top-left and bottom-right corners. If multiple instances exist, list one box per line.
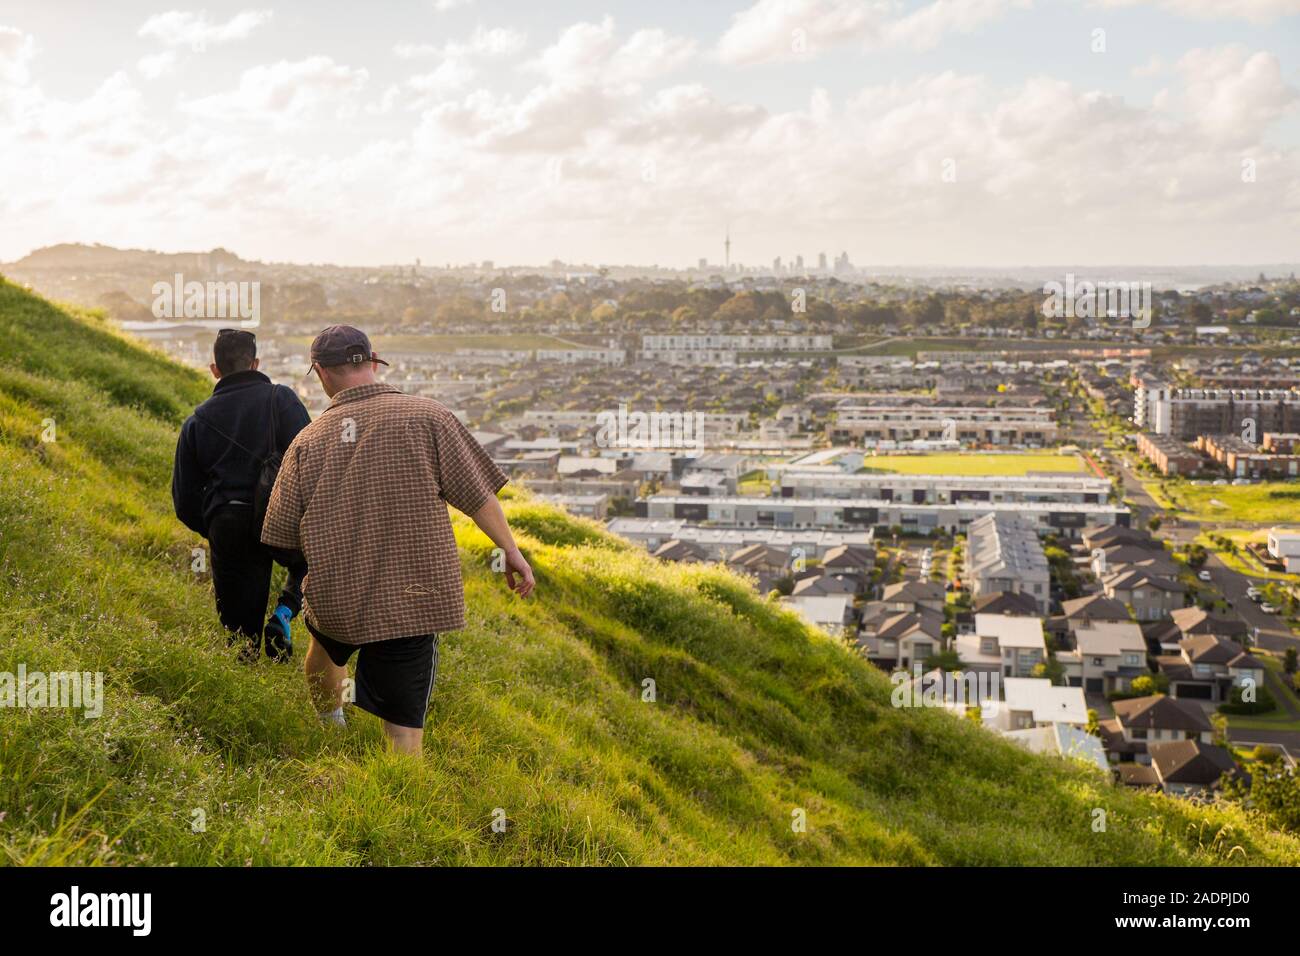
left=307, top=622, right=438, bottom=728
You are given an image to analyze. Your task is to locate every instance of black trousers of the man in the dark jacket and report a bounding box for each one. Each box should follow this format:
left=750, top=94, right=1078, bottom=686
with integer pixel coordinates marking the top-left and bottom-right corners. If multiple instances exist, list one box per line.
left=208, top=505, right=307, bottom=644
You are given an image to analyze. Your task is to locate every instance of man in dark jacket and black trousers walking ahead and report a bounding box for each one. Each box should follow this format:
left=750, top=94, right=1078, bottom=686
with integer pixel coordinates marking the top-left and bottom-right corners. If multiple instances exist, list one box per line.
left=172, top=329, right=311, bottom=659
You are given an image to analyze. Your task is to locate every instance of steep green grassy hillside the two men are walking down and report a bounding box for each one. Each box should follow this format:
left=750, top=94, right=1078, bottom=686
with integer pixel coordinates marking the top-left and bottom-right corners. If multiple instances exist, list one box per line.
left=0, top=277, right=1300, bottom=865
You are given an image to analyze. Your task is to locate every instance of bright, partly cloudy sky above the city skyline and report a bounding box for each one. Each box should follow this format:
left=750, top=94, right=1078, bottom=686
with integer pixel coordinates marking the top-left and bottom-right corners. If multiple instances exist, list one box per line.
left=0, top=0, right=1300, bottom=268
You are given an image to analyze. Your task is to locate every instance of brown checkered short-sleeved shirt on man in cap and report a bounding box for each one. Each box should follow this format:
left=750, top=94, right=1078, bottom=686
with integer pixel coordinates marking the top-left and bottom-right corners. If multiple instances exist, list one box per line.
left=261, top=384, right=506, bottom=644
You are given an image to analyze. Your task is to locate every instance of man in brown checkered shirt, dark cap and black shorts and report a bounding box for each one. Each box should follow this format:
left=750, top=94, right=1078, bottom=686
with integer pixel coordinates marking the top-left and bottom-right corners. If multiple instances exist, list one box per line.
left=261, top=325, right=533, bottom=753
